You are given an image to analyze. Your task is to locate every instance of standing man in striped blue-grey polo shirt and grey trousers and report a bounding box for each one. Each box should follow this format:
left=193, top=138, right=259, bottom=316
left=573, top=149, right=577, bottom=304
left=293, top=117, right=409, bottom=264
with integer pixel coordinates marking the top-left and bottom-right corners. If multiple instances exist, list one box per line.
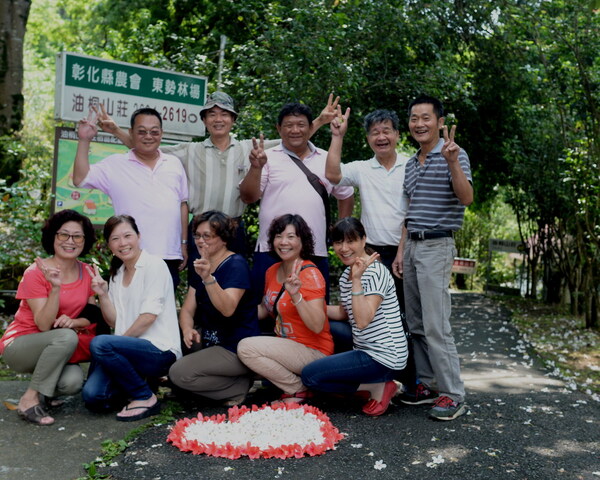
left=393, top=96, right=473, bottom=420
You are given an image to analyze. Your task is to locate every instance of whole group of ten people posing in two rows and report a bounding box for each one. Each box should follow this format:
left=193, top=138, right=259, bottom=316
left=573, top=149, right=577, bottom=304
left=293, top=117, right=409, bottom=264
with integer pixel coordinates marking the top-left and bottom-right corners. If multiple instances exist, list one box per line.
left=0, top=92, right=473, bottom=425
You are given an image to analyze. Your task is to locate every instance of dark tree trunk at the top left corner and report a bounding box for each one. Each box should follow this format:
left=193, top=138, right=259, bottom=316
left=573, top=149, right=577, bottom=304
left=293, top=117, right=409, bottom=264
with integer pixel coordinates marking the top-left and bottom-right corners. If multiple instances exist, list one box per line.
left=0, top=0, right=31, bottom=135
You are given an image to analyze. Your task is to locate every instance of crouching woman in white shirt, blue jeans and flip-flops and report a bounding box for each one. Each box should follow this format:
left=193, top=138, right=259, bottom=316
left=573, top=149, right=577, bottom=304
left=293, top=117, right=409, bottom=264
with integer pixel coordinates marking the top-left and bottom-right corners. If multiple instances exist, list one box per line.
left=83, top=215, right=181, bottom=422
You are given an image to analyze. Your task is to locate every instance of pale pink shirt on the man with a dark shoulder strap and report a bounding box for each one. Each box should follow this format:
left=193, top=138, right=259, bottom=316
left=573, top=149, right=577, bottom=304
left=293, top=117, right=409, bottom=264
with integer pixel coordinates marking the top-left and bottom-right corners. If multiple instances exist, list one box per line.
left=256, top=142, right=354, bottom=257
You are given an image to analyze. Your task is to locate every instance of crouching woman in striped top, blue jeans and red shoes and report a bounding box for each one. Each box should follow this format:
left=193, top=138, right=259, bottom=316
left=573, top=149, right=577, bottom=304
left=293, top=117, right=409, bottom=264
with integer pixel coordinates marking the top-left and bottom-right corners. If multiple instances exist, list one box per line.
left=302, top=217, right=408, bottom=416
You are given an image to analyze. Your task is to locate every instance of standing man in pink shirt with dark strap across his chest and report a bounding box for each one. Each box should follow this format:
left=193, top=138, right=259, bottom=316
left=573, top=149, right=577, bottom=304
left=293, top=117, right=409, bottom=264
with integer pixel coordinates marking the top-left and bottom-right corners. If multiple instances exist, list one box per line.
left=240, top=103, right=354, bottom=304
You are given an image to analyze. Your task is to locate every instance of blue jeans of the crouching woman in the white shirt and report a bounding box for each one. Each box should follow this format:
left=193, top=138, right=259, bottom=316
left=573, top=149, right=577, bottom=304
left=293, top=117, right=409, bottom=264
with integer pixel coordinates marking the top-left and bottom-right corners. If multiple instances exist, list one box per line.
left=82, top=335, right=175, bottom=410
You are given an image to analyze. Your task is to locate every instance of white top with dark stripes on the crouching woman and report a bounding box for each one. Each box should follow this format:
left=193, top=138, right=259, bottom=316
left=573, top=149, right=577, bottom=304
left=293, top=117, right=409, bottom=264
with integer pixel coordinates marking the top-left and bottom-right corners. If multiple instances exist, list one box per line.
left=340, top=262, right=408, bottom=370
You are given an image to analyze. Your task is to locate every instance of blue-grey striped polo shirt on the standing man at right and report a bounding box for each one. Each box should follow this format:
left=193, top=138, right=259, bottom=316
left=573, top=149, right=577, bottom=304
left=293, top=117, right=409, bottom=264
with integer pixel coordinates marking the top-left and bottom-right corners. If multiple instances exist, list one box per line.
left=404, top=138, right=473, bottom=232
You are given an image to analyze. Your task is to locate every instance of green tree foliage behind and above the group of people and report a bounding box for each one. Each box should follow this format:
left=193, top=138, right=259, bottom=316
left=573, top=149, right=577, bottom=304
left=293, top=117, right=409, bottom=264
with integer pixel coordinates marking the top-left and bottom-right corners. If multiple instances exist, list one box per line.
left=3, top=0, right=600, bottom=325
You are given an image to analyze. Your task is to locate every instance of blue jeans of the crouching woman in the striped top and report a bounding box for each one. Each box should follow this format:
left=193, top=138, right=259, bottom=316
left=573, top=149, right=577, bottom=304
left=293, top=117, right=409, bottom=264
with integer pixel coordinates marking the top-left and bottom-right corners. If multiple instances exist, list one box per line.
left=302, top=350, right=396, bottom=393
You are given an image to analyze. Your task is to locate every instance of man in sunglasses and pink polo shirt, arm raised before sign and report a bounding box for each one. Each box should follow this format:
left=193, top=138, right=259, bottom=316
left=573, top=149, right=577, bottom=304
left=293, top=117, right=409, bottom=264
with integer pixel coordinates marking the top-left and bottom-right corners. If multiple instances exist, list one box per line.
left=73, top=108, right=188, bottom=288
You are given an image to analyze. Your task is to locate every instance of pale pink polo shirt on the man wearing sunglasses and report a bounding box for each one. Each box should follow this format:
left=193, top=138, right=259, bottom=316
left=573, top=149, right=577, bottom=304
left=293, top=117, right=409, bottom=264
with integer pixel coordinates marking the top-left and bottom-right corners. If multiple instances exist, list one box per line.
left=79, top=150, right=188, bottom=259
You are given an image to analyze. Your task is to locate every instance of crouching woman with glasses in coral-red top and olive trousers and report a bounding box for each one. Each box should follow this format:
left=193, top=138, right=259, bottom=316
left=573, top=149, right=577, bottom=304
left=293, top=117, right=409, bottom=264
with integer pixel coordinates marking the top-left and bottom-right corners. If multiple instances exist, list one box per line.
left=0, top=210, right=96, bottom=425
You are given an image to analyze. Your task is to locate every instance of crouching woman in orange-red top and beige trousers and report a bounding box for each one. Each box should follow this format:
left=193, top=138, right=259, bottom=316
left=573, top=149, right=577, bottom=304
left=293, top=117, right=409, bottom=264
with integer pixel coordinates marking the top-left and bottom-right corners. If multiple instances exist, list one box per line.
left=238, top=214, right=333, bottom=402
